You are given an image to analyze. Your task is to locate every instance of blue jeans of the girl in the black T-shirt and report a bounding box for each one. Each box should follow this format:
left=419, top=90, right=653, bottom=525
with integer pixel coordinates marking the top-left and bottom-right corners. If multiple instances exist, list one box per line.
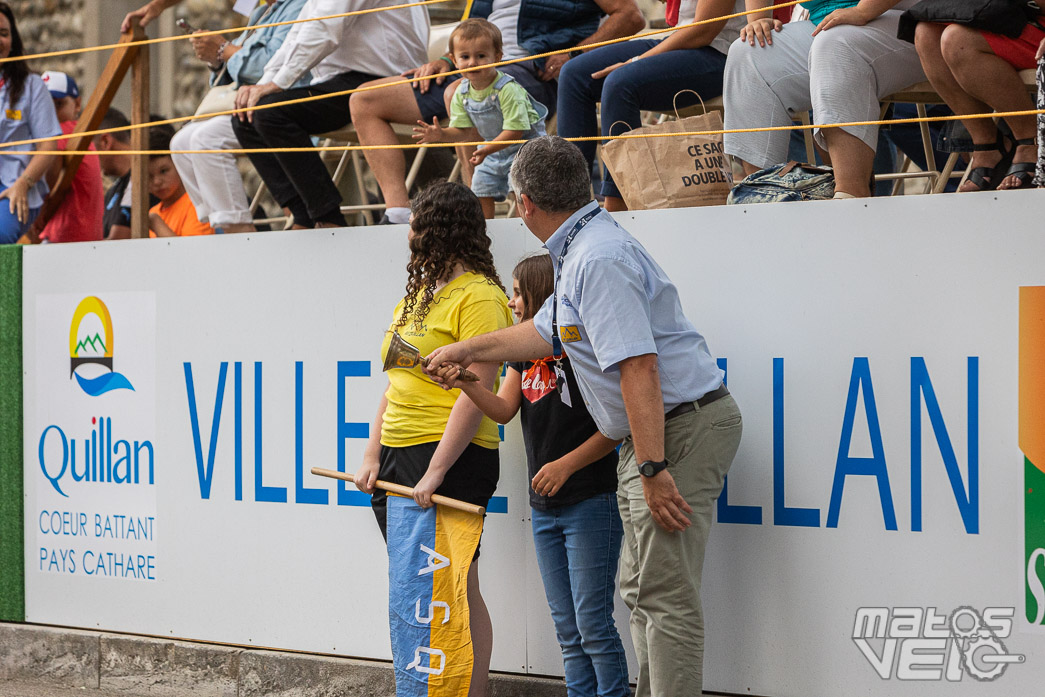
left=532, top=493, right=631, bottom=697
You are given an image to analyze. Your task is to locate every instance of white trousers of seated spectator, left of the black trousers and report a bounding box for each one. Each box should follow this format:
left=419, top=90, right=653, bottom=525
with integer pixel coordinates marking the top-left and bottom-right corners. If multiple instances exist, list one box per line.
left=170, top=116, right=252, bottom=228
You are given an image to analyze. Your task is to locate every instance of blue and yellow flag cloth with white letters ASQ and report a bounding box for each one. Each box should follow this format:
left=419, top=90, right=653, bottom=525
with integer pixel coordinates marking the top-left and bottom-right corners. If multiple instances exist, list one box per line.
left=388, top=495, right=483, bottom=697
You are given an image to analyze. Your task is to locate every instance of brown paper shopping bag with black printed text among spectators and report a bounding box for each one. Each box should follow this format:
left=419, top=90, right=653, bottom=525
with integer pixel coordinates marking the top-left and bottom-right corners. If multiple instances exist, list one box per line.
left=602, top=90, right=733, bottom=210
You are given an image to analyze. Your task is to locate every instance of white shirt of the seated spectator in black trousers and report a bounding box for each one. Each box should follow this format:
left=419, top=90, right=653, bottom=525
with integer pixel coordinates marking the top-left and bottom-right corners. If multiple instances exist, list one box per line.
left=260, top=0, right=428, bottom=90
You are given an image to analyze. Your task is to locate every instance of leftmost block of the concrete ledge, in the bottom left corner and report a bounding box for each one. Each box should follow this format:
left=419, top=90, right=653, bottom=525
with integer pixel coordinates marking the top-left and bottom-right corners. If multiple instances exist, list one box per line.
left=0, top=624, right=99, bottom=689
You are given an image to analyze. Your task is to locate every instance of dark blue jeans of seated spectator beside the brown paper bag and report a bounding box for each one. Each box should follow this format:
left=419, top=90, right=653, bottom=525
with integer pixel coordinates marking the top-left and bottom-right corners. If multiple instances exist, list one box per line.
left=558, top=39, right=725, bottom=196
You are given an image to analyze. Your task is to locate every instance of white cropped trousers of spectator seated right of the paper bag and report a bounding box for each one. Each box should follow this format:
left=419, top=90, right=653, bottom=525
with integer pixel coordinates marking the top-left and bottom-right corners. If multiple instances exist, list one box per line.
left=723, top=9, right=926, bottom=167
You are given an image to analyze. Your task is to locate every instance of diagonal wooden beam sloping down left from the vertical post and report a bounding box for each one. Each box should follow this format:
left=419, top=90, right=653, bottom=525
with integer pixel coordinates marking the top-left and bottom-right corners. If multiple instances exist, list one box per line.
left=30, top=27, right=144, bottom=242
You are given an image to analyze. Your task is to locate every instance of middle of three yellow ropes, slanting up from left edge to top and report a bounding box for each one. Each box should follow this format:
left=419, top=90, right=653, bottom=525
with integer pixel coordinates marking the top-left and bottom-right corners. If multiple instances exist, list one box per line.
left=0, top=0, right=802, bottom=148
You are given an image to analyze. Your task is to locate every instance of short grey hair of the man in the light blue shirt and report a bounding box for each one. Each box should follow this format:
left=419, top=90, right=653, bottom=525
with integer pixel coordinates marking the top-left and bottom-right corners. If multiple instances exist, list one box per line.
left=511, top=136, right=591, bottom=213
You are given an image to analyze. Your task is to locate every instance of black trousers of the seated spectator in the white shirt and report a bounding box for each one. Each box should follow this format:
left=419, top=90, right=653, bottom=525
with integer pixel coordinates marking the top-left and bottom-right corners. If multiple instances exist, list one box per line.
left=231, top=72, right=379, bottom=228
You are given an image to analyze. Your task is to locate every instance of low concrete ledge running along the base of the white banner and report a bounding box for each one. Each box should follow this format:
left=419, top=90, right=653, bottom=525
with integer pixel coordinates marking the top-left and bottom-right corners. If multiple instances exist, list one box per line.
left=0, top=623, right=566, bottom=697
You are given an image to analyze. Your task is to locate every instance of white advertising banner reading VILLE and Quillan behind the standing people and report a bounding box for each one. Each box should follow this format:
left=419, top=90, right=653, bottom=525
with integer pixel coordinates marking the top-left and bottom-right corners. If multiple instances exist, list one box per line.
left=24, top=191, right=1045, bottom=697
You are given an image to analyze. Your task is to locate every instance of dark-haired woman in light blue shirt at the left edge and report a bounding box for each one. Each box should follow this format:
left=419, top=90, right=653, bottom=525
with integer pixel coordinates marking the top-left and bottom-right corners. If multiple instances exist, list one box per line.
left=0, top=2, right=62, bottom=245
